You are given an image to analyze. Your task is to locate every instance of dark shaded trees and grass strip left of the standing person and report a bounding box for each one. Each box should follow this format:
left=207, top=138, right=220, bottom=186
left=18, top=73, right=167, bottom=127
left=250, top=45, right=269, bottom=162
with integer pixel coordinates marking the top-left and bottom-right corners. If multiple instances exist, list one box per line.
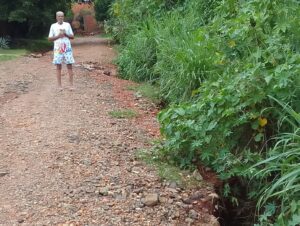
left=0, top=0, right=72, bottom=61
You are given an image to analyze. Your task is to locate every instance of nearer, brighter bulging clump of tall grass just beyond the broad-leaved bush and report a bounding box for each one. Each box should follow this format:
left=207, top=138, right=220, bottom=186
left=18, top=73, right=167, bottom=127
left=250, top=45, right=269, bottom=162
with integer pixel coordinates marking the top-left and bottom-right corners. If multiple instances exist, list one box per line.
left=154, top=13, right=217, bottom=102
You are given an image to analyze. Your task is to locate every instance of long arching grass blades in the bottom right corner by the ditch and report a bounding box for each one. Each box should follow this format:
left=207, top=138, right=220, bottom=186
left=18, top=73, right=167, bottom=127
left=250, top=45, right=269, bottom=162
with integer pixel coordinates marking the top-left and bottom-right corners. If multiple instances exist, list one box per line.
left=252, top=98, right=300, bottom=226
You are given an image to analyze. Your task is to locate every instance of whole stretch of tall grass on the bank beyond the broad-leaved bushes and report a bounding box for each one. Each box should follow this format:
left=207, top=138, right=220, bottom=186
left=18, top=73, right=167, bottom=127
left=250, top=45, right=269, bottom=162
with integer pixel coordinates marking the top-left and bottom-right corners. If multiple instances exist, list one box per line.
left=114, top=0, right=218, bottom=102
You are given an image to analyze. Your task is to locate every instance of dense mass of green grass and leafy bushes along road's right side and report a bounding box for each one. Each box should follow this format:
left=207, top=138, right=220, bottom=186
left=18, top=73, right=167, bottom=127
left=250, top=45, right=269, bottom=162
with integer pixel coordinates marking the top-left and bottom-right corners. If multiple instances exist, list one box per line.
left=106, top=0, right=300, bottom=226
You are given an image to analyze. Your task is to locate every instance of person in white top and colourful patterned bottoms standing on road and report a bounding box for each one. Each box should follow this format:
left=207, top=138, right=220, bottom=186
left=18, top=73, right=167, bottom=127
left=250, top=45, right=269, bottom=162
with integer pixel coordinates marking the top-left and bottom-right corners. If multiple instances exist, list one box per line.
left=48, top=11, right=75, bottom=91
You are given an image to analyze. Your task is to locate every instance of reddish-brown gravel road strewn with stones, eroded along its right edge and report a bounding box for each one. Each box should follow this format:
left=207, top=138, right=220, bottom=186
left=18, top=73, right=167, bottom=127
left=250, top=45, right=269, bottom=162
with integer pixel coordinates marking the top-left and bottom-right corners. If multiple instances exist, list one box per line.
left=0, top=37, right=218, bottom=226
